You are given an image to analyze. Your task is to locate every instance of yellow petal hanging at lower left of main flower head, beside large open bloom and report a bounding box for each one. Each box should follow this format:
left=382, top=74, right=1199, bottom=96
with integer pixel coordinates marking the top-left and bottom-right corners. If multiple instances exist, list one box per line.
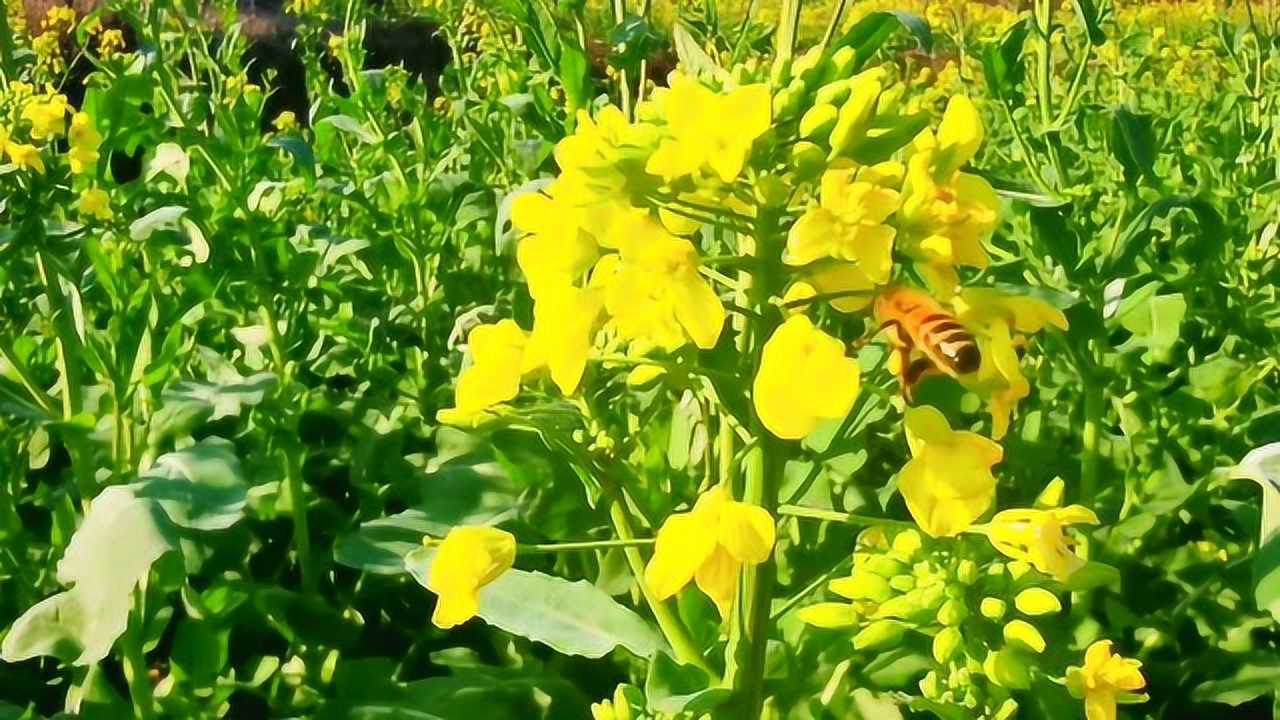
left=524, top=286, right=604, bottom=395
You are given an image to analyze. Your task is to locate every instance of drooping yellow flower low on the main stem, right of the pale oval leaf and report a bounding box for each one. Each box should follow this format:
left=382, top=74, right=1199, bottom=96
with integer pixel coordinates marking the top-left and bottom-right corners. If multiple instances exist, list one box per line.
left=644, top=487, right=774, bottom=618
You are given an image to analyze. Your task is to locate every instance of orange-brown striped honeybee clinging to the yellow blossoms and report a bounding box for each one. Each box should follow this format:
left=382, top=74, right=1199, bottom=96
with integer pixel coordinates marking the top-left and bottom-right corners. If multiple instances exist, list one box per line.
left=873, top=287, right=982, bottom=401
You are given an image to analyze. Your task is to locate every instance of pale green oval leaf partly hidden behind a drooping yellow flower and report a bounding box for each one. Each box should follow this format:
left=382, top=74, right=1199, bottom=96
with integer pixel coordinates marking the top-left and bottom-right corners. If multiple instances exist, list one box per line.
left=404, top=547, right=663, bottom=657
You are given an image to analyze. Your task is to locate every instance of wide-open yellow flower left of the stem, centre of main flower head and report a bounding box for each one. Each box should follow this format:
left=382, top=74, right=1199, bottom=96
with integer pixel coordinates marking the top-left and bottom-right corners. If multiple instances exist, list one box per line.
left=591, top=214, right=724, bottom=354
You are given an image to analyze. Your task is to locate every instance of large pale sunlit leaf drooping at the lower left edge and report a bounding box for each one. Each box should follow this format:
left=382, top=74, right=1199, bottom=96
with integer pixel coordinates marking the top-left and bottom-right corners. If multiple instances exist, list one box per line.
left=0, top=486, right=175, bottom=665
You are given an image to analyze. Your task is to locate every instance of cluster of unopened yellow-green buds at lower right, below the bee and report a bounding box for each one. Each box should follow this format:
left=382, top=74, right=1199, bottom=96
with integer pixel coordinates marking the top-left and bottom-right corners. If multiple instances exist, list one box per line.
left=800, top=528, right=1062, bottom=720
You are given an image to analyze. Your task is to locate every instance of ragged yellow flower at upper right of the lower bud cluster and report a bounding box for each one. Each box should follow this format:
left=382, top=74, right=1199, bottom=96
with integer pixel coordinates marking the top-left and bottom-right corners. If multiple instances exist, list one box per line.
left=987, top=505, right=1098, bottom=582
